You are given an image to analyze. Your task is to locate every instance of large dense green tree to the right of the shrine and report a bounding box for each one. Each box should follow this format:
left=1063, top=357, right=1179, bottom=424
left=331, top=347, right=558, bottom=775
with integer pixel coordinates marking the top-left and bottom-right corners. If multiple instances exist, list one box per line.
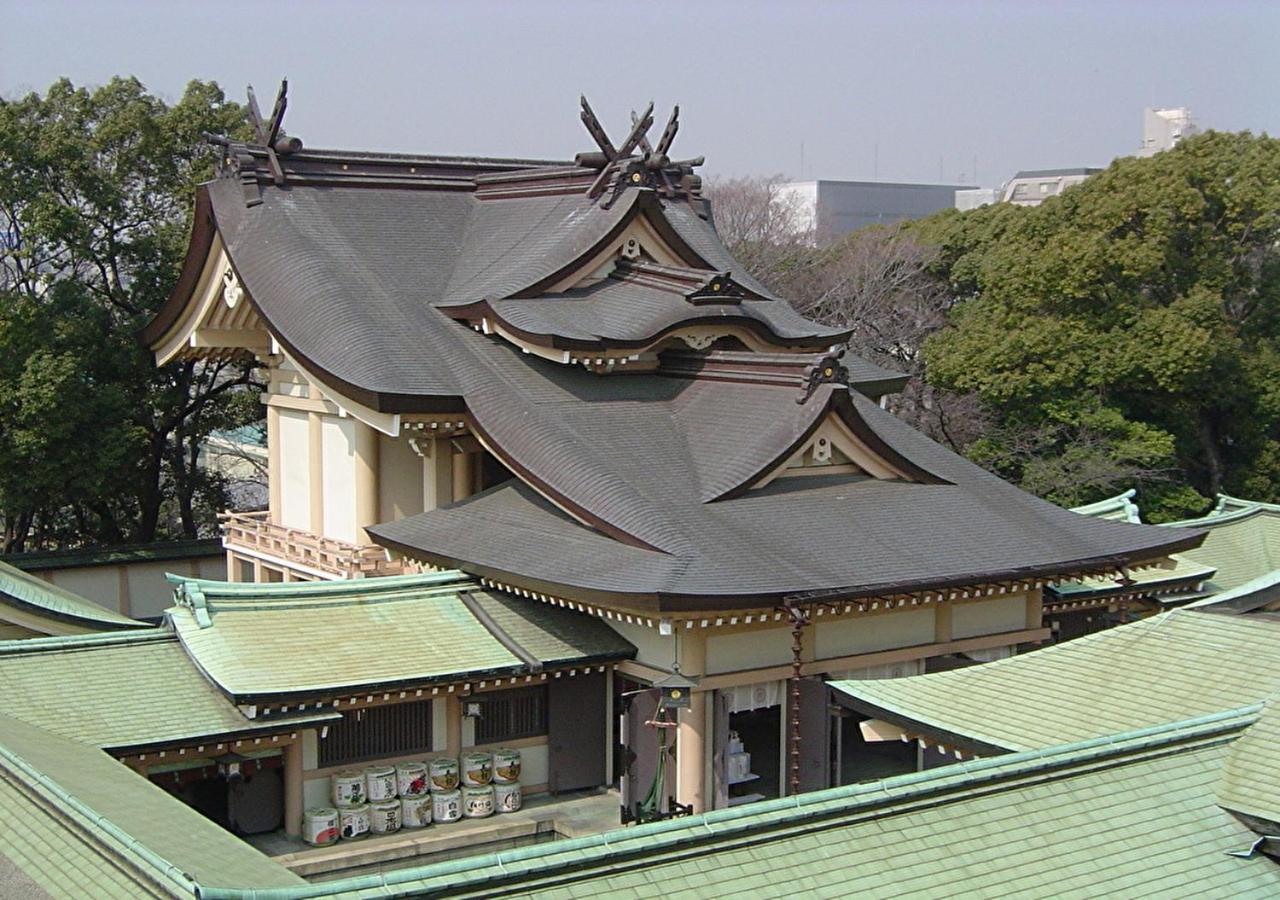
left=915, top=132, right=1280, bottom=520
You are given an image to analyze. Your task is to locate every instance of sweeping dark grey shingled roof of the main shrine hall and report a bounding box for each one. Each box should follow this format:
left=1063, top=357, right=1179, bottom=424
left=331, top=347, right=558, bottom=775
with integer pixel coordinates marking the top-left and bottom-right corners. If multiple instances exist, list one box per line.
left=185, top=161, right=1199, bottom=599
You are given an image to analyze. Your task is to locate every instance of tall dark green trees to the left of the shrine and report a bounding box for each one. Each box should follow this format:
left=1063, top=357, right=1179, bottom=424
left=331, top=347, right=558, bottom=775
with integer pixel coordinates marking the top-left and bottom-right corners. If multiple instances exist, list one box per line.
left=0, top=78, right=256, bottom=552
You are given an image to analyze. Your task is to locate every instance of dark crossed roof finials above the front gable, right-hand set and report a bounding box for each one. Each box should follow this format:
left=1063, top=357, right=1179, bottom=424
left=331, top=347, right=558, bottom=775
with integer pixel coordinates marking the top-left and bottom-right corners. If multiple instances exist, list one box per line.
left=573, top=97, right=704, bottom=206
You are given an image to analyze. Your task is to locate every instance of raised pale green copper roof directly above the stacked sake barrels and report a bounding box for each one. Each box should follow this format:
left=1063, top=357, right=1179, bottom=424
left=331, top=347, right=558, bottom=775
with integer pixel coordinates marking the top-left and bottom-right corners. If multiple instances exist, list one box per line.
left=169, top=571, right=635, bottom=702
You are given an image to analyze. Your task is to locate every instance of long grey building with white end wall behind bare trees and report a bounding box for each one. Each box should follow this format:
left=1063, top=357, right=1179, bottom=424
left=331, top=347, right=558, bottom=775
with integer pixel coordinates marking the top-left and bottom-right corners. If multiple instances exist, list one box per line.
left=781, top=181, right=973, bottom=243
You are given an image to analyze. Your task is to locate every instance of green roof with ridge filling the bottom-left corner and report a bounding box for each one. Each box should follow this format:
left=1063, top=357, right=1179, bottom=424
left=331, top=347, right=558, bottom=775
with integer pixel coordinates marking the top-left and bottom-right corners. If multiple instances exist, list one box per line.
left=0, top=714, right=306, bottom=900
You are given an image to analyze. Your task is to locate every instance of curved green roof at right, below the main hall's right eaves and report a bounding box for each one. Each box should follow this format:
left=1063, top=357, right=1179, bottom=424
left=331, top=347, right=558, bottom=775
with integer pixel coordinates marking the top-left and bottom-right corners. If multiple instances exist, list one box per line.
left=832, top=609, right=1280, bottom=751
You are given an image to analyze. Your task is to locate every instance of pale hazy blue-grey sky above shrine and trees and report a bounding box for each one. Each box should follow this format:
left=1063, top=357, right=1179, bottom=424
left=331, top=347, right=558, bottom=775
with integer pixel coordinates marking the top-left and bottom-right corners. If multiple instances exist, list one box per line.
left=0, top=0, right=1280, bottom=186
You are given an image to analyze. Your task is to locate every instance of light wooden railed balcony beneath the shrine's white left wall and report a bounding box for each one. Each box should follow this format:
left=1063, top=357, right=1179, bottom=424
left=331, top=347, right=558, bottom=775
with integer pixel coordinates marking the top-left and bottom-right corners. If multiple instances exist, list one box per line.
left=218, top=511, right=408, bottom=579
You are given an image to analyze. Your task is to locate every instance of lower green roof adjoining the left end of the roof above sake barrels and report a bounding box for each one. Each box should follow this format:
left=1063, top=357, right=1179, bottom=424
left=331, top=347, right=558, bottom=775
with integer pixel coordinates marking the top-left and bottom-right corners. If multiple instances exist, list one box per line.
left=0, top=629, right=335, bottom=749
